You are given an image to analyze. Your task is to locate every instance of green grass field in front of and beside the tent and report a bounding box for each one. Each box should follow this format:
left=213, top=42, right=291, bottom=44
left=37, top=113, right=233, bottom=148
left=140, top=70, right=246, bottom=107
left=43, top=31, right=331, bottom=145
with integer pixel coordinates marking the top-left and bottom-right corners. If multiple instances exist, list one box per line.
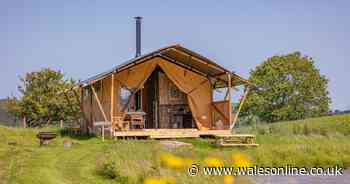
left=0, top=115, right=350, bottom=184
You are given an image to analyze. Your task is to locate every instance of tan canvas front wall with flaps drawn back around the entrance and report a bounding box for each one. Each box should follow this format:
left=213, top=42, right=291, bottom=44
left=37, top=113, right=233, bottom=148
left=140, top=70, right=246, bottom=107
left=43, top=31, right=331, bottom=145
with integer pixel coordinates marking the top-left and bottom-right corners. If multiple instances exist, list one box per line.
left=116, top=57, right=212, bottom=129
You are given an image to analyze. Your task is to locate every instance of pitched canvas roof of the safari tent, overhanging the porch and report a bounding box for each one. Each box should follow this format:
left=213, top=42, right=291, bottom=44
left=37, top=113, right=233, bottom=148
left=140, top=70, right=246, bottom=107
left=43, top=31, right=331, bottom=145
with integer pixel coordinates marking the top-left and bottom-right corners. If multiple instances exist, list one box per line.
left=77, top=45, right=250, bottom=88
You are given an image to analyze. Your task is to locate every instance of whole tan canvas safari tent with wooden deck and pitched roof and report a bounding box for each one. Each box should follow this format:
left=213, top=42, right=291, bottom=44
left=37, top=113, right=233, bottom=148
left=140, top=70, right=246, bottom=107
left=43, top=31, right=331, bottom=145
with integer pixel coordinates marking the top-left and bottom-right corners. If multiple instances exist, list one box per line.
left=77, top=45, right=250, bottom=137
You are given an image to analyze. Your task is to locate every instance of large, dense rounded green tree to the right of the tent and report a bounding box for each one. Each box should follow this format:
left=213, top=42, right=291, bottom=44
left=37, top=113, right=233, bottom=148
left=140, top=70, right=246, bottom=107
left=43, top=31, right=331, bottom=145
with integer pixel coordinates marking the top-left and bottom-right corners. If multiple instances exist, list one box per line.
left=243, top=52, right=331, bottom=122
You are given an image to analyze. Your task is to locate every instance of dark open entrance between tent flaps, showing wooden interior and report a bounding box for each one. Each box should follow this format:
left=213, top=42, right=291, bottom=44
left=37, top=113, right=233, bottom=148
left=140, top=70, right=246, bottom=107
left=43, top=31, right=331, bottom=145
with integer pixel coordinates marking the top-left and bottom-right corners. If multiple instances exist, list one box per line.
left=141, top=67, right=196, bottom=129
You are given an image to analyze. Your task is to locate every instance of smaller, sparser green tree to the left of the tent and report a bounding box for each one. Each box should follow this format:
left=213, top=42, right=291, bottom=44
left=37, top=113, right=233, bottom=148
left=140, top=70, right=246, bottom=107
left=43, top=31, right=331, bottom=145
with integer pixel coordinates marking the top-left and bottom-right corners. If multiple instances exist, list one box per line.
left=7, top=68, right=80, bottom=127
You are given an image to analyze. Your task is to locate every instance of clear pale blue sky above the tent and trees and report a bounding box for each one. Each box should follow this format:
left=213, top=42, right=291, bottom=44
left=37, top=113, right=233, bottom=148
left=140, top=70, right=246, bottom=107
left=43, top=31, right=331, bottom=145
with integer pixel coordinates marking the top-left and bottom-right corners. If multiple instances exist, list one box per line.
left=0, top=0, right=350, bottom=109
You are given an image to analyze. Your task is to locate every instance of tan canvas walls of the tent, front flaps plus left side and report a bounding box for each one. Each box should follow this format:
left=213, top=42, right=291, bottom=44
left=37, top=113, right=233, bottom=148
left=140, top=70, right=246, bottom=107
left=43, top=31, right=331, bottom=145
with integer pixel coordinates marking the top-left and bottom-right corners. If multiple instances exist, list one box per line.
left=83, top=57, right=212, bottom=130
